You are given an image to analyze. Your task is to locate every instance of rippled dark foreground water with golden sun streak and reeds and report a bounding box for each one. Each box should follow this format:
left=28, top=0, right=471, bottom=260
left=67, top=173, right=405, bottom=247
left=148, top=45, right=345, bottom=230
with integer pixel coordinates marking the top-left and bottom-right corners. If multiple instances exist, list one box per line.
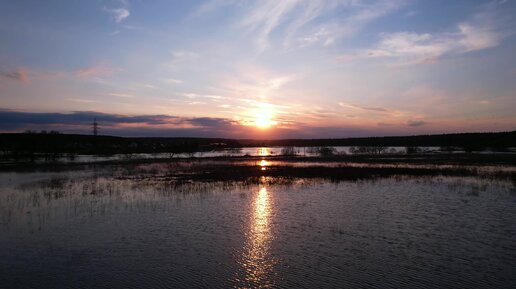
left=0, top=163, right=516, bottom=288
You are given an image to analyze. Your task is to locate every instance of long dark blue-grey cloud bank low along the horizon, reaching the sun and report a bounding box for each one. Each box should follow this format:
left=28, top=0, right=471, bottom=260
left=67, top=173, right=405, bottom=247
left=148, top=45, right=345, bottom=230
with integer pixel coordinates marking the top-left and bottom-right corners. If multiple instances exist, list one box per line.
left=0, top=109, right=404, bottom=139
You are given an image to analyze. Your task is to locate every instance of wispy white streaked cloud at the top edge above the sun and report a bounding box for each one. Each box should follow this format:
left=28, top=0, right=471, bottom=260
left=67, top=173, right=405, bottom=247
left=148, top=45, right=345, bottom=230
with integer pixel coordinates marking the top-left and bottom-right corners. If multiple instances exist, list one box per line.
left=204, top=0, right=408, bottom=51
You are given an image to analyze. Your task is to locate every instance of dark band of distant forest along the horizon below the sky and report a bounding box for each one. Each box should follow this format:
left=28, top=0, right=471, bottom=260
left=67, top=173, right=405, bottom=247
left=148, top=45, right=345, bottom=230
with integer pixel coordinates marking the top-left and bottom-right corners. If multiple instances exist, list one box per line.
left=0, top=131, right=516, bottom=156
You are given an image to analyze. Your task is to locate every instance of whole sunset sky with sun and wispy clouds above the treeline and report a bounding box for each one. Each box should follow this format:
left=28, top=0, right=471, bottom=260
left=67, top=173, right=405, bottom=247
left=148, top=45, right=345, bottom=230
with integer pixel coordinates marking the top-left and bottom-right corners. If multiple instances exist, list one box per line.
left=0, top=0, right=516, bottom=139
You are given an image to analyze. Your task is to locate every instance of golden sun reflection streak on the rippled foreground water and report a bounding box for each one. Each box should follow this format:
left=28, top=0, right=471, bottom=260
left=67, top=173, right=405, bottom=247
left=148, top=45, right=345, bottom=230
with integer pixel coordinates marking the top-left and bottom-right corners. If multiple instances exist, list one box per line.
left=237, top=186, right=275, bottom=288
